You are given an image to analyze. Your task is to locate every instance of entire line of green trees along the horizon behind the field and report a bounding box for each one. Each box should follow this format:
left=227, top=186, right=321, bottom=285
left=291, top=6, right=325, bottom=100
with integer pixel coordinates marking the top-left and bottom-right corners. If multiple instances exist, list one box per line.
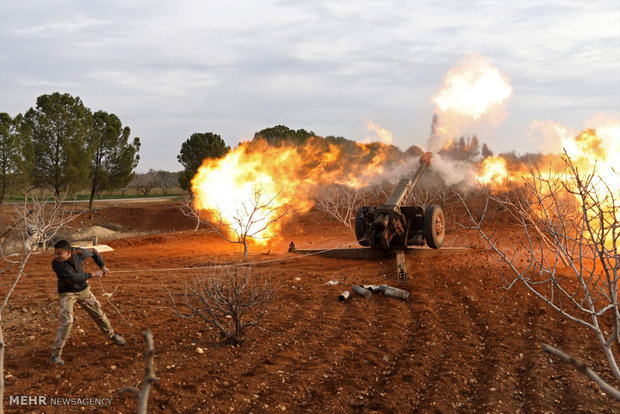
left=0, top=92, right=498, bottom=207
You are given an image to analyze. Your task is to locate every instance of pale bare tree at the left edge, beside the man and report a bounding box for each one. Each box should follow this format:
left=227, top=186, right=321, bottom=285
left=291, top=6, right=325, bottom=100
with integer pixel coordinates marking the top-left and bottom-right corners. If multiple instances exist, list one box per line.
left=0, top=194, right=77, bottom=414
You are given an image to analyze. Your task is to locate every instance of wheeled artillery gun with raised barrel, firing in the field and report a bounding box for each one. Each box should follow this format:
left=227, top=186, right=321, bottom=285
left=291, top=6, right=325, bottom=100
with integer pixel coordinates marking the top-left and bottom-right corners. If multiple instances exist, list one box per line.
left=355, top=152, right=445, bottom=279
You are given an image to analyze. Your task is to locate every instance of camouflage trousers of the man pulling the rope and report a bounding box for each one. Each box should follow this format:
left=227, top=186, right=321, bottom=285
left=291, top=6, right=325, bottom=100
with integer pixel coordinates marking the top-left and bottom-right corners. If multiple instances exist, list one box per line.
left=52, top=287, right=114, bottom=357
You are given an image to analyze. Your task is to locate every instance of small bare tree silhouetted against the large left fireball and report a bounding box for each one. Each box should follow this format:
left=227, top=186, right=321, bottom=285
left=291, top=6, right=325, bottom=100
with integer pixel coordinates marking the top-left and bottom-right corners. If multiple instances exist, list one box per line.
left=205, top=186, right=289, bottom=260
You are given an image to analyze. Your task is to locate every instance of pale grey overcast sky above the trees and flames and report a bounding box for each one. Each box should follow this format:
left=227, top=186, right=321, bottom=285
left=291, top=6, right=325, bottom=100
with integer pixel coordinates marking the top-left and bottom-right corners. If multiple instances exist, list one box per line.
left=0, top=0, right=620, bottom=171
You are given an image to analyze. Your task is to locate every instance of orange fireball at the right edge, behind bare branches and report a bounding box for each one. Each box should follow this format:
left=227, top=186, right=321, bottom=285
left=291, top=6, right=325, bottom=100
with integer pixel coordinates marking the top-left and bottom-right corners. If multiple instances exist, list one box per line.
left=476, top=124, right=620, bottom=248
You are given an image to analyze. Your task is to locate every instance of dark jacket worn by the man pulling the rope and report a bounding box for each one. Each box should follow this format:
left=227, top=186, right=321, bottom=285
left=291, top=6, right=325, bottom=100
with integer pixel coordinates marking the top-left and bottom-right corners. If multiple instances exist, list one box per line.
left=52, top=249, right=103, bottom=293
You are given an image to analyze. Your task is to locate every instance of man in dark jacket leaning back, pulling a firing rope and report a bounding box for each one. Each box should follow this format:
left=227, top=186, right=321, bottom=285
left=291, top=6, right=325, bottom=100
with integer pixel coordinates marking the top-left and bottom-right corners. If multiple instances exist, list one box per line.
left=52, top=240, right=125, bottom=365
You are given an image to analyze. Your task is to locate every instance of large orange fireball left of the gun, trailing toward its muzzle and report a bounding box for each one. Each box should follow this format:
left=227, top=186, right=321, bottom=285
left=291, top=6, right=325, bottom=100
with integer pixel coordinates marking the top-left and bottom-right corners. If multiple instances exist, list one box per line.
left=192, top=138, right=398, bottom=244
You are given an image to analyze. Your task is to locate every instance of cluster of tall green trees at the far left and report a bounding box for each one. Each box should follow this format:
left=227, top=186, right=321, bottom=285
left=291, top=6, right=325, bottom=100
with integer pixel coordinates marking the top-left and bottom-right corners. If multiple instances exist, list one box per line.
left=0, top=92, right=140, bottom=207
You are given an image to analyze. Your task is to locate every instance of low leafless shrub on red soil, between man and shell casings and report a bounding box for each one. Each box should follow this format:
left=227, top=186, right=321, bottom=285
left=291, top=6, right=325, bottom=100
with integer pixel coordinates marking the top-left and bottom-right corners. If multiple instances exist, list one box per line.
left=164, top=266, right=275, bottom=345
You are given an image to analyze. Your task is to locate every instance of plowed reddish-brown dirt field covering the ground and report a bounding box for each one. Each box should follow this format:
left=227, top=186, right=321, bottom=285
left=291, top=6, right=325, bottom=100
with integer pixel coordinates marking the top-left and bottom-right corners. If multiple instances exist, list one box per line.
left=2, top=203, right=620, bottom=413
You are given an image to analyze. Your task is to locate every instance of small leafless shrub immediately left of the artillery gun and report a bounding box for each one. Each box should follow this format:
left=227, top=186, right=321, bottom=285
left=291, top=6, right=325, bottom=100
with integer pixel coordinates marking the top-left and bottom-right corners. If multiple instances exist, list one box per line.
left=314, top=184, right=367, bottom=228
